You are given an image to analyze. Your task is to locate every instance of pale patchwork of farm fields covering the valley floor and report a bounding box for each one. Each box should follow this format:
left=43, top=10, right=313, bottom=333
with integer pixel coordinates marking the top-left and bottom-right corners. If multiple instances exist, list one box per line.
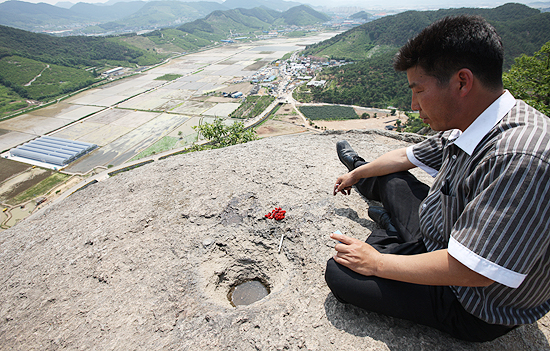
left=0, top=33, right=350, bottom=231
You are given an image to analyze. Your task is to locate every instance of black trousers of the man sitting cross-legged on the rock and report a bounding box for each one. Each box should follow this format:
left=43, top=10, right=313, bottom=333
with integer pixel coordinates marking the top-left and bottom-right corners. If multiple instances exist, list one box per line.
left=325, top=164, right=515, bottom=341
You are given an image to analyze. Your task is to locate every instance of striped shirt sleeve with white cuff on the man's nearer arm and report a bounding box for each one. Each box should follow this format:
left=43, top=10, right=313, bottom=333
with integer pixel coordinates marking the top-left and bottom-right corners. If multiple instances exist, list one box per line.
left=448, top=154, right=550, bottom=288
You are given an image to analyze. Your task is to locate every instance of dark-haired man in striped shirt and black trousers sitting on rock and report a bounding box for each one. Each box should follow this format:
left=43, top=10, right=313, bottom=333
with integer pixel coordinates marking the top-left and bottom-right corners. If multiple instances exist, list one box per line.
left=325, top=16, right=550, bottom=341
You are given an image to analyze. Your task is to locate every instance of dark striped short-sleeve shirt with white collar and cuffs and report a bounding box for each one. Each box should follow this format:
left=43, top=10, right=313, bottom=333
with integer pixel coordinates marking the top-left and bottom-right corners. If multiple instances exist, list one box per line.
left=407, top=92, right=550, bottom=325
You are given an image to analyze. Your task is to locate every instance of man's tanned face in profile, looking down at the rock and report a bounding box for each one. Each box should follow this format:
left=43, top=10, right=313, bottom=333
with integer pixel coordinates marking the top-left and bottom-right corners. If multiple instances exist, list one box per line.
left=407, top=66, right=457, bottom=131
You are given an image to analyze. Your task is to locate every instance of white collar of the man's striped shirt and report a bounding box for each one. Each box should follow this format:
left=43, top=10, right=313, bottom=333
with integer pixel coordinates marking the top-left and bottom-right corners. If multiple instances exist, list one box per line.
left=453, top=90, right=516, bottom=156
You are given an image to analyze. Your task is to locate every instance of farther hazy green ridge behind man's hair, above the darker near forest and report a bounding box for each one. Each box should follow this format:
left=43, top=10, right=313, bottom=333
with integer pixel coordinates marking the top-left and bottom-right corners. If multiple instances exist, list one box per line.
left=306, top=4, right=550, bottom=67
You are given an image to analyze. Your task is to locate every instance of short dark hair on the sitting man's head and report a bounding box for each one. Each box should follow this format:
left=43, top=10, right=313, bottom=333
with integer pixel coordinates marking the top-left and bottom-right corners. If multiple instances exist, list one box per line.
left=393, top=15, right=504, bottom=89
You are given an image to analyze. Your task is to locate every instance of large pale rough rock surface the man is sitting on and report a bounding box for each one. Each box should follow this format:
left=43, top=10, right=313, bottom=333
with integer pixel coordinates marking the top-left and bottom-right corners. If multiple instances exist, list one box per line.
left=0, top=132, right=550, bottom=350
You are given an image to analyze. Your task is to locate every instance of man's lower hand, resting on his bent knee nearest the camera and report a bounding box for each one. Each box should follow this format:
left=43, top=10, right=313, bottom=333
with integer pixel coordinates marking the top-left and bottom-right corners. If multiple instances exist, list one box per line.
left=330, top=233, right=382, bottom=276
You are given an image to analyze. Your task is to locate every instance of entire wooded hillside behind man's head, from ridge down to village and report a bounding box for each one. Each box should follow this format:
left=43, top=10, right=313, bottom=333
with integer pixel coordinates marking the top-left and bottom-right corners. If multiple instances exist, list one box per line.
left=303, top=4, right=550, bottom=109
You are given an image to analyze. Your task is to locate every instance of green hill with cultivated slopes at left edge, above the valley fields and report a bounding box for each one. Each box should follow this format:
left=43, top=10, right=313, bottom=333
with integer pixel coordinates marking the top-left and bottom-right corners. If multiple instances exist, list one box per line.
left=0, top=26, right=165, bottom=112
